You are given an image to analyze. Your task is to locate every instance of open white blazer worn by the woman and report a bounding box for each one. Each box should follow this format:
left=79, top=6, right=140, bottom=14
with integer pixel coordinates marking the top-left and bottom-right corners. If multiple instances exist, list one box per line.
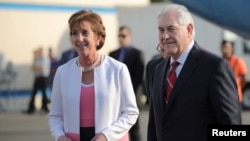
left=48, top=55, right=139, bottom=141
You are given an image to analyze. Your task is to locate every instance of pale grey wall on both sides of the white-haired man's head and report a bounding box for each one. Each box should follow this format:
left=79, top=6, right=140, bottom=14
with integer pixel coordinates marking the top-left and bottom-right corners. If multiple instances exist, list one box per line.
left=117, top=3, right=222, bottom=62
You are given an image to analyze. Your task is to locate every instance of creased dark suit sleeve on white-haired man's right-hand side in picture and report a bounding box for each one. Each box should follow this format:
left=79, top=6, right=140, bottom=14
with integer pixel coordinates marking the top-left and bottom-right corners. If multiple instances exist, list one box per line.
left=209, top=60, right=241, bottom=124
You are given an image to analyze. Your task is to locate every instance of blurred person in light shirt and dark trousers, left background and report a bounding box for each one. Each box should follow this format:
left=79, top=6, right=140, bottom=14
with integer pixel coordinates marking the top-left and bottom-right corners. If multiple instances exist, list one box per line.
left=25, top=47, right=50, bottom=114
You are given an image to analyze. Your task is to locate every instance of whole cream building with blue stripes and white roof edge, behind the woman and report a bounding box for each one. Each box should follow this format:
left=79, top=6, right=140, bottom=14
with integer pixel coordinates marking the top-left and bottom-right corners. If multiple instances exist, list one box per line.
left=0, top=0, right=149, bottom=111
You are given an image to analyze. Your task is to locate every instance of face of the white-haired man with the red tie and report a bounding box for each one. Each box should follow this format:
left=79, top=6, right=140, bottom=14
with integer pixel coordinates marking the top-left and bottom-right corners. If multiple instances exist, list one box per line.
left=158, top=12, right=193, bottom=58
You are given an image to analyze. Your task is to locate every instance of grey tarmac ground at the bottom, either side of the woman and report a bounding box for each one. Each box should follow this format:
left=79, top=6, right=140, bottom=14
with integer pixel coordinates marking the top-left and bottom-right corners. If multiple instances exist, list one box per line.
left=0, top=109, right=250, bottom=141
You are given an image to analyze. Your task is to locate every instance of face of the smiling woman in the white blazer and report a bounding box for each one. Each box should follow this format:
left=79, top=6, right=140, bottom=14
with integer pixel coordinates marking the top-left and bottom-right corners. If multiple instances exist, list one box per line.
left=71, top=21, right=100, bottom=57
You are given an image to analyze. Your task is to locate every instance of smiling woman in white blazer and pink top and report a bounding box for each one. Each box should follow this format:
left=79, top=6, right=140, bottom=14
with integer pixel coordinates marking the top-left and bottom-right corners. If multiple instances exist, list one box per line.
left=48, top=10, right=139, bottom=141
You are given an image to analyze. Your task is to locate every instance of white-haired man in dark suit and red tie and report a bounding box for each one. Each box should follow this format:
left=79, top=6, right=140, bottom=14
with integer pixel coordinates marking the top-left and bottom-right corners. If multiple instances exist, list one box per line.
left=147, top=4, right=241, bottom=141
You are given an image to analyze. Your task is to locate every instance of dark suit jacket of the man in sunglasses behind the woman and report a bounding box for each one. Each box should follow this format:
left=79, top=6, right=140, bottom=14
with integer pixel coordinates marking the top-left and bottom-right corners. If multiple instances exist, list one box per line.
left=109, top=47, right=145, bottom=93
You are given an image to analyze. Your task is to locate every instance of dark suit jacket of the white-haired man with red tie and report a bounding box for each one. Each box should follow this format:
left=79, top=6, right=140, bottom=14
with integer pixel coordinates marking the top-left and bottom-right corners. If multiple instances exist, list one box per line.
left=148, top=43, right=241, bottom=141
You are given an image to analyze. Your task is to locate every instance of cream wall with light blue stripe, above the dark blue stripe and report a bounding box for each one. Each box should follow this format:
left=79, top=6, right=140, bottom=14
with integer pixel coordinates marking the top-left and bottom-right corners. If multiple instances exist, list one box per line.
left=0, top=2, right=118, bottom=89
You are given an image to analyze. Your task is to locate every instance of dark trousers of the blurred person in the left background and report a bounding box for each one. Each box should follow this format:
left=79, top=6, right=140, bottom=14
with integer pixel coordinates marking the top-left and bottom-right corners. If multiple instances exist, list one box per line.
left=28, top=76, right=49, bottom=112
